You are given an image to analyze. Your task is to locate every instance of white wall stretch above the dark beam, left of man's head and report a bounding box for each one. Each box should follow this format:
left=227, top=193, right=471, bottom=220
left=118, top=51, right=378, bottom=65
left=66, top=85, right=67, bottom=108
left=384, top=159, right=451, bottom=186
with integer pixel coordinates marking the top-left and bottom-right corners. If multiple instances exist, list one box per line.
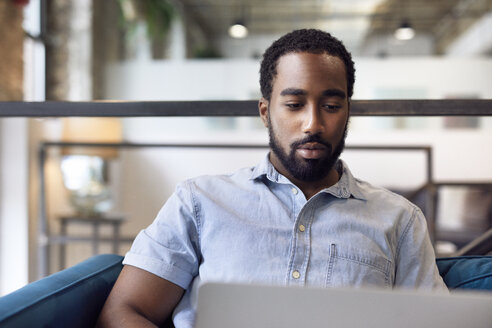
left=106, top=59, right=259, bottom=100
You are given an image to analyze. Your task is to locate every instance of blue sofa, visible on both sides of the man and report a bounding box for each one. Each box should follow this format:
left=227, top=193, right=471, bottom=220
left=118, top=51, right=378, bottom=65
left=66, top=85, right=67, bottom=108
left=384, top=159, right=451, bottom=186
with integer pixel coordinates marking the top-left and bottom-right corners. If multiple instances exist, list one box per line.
left=0, top=254, right=492, bottom=328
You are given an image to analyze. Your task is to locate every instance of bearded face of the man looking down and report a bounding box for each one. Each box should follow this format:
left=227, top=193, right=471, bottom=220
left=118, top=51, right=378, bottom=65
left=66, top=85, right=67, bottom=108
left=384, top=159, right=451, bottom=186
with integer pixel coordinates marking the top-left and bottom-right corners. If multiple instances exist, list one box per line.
left=259, top=52, right=349, bottom=182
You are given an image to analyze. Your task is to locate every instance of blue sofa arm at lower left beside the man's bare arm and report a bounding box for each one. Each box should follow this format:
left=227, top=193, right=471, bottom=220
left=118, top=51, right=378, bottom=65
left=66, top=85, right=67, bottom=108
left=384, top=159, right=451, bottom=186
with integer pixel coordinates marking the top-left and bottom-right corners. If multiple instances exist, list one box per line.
left=0, top=254, right=123, bottom=328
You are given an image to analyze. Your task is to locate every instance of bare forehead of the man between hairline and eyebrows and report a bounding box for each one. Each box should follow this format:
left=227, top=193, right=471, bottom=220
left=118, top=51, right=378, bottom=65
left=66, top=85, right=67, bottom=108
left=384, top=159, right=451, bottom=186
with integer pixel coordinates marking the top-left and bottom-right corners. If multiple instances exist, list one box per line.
left=272, top=52, right=347, bottom=93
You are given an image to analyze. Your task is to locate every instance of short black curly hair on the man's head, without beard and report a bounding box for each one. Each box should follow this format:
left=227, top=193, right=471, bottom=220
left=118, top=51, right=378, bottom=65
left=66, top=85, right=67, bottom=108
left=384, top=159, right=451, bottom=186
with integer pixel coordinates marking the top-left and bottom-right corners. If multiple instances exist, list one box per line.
left=260, top=29, right=355, bottom=100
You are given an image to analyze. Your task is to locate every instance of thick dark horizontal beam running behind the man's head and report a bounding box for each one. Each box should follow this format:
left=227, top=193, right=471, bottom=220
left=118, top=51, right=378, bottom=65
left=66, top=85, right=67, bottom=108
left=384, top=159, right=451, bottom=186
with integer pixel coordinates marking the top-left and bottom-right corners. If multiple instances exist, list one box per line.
left=0, top=99, right=492, bottom=117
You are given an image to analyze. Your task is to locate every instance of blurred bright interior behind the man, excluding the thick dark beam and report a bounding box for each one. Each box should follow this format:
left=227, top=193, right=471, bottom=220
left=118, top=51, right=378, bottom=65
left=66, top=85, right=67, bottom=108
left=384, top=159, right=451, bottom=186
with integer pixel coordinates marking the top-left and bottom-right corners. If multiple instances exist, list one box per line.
left=0, top=0, right=492, bottom=295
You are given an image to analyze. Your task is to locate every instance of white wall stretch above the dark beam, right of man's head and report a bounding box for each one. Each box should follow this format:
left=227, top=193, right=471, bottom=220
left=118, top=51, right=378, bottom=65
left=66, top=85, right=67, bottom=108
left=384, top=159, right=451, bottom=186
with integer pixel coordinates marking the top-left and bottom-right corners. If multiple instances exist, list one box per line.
left=354, top=57, right=492, bottom=99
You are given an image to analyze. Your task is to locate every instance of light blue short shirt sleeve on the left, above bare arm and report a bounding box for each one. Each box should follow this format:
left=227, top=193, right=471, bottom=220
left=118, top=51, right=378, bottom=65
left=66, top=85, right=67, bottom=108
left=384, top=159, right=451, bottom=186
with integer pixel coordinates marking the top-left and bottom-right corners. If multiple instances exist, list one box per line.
left=123, top=182, right=199, bottom=289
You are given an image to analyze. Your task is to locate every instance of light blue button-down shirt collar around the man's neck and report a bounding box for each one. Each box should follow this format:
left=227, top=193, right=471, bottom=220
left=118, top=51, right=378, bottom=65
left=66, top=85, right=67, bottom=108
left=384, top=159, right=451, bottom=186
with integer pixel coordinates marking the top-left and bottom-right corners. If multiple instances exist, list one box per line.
left=250, top=153, right=367, bottom=200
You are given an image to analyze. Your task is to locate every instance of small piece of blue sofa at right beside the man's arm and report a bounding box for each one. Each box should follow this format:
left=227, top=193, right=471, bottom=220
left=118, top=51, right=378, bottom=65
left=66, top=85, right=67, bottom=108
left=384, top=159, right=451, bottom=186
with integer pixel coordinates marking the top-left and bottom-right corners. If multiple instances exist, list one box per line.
left=436, top=256, right=492, bottom=290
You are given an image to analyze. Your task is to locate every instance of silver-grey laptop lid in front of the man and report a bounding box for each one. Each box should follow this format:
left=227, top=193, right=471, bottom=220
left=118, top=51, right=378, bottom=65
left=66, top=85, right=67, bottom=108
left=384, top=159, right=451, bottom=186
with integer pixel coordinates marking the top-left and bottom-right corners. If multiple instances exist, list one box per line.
left=195, top=283, right=492, bottom=328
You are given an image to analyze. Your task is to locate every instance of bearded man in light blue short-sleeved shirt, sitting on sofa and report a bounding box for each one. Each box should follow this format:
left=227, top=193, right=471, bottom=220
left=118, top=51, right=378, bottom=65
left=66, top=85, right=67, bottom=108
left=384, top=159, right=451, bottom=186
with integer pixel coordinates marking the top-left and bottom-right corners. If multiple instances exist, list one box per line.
left=100, top=30, right=446, bottom=328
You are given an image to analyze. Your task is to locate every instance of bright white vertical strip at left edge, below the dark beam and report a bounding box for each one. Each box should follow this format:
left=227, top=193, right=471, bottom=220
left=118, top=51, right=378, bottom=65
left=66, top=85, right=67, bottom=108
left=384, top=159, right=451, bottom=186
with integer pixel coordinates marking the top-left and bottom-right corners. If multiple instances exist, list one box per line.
left=0, top=118, right=28, bottom=295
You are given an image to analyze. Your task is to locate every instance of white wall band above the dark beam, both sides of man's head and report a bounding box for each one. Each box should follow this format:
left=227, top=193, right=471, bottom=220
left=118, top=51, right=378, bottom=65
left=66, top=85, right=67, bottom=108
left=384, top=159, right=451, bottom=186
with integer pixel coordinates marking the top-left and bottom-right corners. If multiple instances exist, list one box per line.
left=106, top=57, right=492, bottom=100
